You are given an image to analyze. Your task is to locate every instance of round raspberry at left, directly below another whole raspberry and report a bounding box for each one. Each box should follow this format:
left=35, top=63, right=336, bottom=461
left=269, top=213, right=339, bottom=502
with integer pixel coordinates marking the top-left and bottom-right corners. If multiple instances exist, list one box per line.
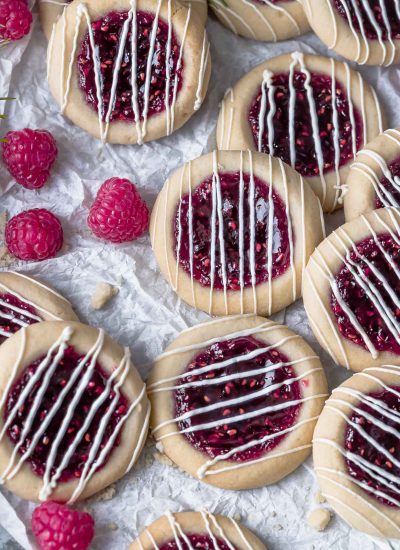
left=5, top=208, right=63, bottom=260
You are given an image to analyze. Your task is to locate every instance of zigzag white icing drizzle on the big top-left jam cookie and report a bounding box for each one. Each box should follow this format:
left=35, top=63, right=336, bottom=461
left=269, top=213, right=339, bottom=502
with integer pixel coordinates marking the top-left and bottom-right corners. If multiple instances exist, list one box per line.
left=54, top=0, right=210, bottom=145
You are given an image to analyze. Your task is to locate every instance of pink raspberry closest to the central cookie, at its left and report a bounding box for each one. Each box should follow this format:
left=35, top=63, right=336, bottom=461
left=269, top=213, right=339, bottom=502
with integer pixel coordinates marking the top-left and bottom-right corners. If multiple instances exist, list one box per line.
left=88, top=178, right=149, bottom=243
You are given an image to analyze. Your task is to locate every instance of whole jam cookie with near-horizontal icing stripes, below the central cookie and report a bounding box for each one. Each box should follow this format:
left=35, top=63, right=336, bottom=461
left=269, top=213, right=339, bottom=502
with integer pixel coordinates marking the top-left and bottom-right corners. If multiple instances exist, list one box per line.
left=148, top=315, right=327, bottom=490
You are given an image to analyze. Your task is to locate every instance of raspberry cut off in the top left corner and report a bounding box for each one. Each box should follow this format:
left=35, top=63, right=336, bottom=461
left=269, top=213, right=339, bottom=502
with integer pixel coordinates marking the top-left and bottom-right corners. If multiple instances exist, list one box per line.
left=0, top=0, right=32, bottom=41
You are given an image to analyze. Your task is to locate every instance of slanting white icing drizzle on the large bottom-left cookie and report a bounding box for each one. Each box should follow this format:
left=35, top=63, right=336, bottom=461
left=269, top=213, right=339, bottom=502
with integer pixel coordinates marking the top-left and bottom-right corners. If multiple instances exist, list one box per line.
left=0, top=327, right=150, bottom=502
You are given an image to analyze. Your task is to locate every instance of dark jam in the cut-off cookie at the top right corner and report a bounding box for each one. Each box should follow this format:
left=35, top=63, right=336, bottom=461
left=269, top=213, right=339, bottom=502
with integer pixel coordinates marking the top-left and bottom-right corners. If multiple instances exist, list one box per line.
left=334, top=0, right=400, bottom=40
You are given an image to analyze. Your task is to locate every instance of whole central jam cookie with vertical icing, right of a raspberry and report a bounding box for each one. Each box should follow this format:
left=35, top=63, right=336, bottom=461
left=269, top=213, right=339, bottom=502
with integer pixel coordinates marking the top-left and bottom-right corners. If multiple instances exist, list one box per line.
left=150, top=151, right=323, bottom=315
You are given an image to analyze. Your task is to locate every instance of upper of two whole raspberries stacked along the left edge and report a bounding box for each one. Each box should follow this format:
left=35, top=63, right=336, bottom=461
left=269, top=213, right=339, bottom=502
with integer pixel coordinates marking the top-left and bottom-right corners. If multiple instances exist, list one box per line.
left=0, top=130, right=58, bottom=189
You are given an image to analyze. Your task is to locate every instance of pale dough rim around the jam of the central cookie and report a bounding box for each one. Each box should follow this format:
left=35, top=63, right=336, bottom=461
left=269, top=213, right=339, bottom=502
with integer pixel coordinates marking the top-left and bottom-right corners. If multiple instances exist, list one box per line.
left=150, top=151, right=324, bottom=315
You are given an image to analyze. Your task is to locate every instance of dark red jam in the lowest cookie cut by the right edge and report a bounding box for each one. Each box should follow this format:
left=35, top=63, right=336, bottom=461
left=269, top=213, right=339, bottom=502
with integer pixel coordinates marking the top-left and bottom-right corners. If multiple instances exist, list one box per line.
left=345, top=387, right=400, bottom=506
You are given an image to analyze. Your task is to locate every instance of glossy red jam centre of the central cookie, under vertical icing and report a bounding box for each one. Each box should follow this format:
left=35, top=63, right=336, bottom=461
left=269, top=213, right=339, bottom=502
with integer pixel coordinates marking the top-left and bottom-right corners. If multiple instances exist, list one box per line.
left=174, top=172, right=290, bottom=290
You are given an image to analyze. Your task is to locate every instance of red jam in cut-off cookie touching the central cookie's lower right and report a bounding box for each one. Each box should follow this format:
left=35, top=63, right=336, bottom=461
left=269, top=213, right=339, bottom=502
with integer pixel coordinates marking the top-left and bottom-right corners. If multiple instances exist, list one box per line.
left=330, top=234, right=400, bottom=355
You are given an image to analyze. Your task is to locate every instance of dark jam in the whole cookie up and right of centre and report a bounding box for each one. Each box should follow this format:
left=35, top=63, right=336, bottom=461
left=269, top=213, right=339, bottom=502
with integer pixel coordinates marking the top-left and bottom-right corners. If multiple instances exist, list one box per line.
left=248, top=71, right=362, bottom=177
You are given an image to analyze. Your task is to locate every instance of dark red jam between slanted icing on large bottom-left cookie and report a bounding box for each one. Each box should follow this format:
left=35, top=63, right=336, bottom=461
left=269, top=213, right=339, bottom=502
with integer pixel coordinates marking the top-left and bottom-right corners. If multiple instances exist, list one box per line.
left=4, top=347, right=128, bottom=482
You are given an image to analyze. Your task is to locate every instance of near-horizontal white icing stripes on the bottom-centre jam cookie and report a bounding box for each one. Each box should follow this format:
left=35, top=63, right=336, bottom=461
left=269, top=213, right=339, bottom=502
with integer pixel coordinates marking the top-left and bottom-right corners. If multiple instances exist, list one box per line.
left=148, top=322, right=326, bottom=479
